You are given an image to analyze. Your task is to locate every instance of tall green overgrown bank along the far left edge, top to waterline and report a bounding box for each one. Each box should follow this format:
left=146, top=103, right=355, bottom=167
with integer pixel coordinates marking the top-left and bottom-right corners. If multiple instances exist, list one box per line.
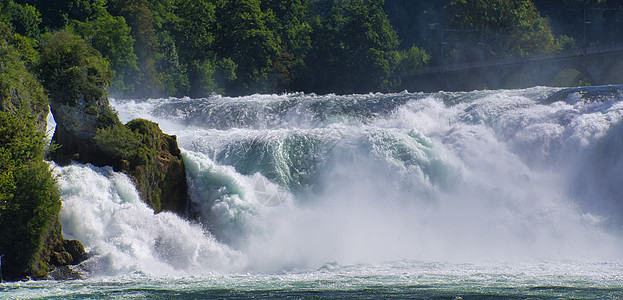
left=0, top=23, right=61, bottom=280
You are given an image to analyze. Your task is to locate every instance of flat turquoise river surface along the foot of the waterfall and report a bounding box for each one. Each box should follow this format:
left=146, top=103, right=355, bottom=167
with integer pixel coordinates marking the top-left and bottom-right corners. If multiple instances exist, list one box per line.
left=2, top=262, right=623, bottom=299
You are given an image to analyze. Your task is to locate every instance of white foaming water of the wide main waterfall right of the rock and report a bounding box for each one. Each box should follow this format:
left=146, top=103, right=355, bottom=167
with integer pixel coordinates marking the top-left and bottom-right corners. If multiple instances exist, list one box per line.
left=73, top=88, right=623, bottom=270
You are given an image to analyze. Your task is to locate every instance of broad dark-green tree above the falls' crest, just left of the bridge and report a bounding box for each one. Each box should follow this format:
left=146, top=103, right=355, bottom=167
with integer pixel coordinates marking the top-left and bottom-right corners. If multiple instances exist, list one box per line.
left=304, top=0, right=399, bottom=93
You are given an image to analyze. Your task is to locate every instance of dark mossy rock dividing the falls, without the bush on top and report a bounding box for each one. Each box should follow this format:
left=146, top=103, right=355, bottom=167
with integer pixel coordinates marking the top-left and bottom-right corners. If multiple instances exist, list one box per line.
left=51, top=97, right=188, bottom=215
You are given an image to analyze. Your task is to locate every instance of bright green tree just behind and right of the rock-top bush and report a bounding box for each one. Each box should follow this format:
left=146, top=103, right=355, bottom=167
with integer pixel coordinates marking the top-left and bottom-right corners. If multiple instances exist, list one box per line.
left=73, top=12, right=138, bottom=93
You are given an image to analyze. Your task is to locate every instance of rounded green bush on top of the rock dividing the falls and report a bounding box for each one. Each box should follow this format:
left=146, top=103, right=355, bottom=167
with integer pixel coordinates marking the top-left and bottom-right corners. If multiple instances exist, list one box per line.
left=38, top=30, right=113, bottom=105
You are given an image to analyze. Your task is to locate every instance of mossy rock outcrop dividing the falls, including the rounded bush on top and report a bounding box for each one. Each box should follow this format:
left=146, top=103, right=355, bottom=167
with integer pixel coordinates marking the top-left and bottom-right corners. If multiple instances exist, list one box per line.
left=40, top=31, right=188, bottom=214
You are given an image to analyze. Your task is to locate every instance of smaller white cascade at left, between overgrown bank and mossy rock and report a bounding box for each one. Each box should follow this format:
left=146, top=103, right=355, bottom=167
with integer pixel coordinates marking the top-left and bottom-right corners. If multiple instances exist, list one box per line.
left=55, top=164, right=245, bottom=276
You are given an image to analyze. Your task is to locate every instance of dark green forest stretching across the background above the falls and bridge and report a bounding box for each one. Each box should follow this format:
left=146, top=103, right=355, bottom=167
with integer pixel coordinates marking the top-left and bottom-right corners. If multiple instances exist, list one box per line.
left=0, top=0, right=623, bottom=97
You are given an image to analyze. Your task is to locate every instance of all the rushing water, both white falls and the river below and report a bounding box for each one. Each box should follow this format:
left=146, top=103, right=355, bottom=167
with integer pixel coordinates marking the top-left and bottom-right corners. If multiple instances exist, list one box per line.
left=0, top=88, right=623, bottom=299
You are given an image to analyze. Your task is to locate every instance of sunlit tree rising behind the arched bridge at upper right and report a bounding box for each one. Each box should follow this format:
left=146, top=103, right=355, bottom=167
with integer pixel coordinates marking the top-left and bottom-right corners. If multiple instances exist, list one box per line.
left=447, top=0, right=557, bottom=56
